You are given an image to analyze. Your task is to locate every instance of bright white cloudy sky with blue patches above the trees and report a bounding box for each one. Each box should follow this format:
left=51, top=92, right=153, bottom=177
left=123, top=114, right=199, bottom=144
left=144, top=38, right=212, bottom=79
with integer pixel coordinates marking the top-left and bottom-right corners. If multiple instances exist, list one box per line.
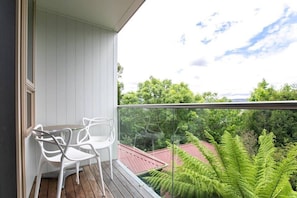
left=118, top=0, right=297, bottom=98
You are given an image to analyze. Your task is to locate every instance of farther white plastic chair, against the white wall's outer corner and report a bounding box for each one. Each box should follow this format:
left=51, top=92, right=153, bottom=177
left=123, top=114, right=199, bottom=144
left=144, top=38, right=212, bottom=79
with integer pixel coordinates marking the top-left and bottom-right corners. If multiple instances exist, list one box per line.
left=77, top=117, right=115, bottom=179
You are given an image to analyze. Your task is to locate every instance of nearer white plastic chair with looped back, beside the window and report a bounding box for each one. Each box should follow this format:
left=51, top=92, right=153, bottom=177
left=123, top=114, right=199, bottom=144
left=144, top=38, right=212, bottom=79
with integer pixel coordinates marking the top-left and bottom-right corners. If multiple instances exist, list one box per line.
left=32, top=124, right=105, bottom=198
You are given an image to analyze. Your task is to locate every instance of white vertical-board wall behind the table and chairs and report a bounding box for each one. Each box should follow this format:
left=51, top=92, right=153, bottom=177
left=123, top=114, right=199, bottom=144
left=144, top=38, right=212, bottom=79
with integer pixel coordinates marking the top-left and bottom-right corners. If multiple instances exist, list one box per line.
left=26, top=9, right=117, bottom=195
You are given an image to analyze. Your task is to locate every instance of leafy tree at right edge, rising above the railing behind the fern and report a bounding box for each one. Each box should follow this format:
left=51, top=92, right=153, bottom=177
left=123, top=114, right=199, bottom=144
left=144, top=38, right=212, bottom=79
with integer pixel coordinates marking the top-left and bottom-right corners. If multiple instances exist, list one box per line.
left=244, top=80, right=297, bottom=146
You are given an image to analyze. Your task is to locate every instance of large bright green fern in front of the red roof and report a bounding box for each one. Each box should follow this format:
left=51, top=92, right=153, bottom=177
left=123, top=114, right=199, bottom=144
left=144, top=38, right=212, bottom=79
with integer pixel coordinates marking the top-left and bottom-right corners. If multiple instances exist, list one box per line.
left=145, top=130, right=297, bottom=198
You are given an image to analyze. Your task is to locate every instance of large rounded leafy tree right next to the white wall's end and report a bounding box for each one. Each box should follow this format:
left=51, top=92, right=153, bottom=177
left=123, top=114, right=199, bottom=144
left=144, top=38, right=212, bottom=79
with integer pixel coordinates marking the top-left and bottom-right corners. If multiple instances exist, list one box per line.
left=120, top=77, right=197, bottom=150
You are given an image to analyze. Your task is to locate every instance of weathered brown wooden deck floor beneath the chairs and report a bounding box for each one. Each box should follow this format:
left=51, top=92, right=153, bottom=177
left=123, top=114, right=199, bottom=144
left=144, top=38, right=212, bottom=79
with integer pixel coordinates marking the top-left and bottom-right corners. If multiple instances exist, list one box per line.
left=29, top=161, right=159, bottom=198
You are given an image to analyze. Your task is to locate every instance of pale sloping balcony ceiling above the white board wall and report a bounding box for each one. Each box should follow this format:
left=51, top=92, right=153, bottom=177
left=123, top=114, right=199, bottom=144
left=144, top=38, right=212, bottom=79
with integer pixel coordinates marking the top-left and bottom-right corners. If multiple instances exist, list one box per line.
left=36, top=0, right=145, bottom=32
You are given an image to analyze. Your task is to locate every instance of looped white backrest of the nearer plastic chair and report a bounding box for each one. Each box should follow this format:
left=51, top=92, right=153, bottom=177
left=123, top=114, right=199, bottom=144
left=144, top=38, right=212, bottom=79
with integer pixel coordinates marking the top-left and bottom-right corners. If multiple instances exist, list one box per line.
left=32, top=125, right=72, bottom=161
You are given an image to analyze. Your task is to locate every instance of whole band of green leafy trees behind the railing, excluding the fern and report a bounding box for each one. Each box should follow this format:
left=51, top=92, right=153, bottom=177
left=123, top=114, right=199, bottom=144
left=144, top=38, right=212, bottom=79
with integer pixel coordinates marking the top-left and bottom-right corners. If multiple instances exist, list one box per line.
left=118, top=65, right=297, bottom=189
